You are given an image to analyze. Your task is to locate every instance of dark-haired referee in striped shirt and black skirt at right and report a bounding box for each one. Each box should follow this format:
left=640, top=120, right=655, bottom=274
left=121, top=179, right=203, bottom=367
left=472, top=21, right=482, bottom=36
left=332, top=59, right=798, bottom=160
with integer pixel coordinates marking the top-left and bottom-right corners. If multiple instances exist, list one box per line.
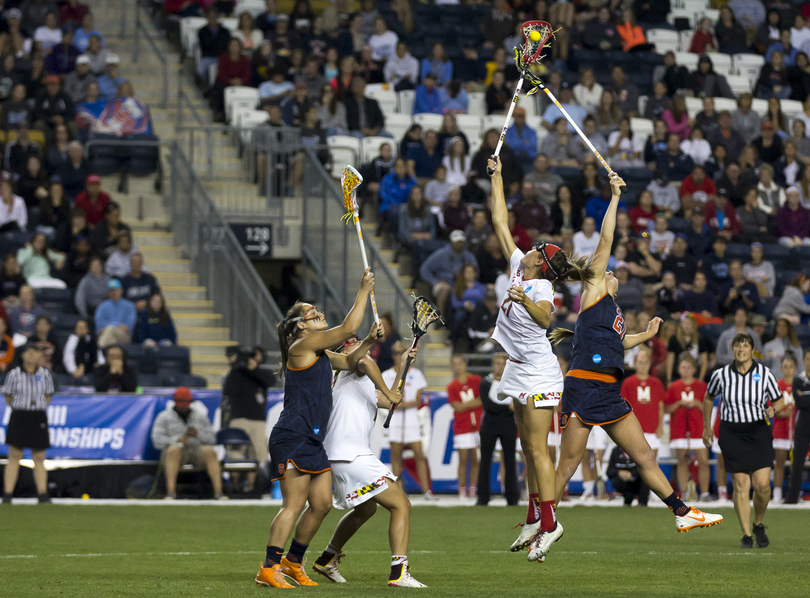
left=703, top=332, right=784, bottom=548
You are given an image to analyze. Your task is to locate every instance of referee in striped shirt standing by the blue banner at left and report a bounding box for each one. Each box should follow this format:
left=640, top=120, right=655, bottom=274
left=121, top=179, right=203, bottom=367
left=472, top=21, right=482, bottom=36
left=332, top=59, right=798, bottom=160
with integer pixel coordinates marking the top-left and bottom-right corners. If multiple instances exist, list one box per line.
left=3, top=344, right=53, bottom=503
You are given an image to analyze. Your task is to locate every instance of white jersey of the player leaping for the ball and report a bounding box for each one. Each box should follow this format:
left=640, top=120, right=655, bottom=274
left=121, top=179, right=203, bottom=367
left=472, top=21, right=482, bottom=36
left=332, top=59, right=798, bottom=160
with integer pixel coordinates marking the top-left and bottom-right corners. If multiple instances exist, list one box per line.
left=492, top=249, right=559, bottom=370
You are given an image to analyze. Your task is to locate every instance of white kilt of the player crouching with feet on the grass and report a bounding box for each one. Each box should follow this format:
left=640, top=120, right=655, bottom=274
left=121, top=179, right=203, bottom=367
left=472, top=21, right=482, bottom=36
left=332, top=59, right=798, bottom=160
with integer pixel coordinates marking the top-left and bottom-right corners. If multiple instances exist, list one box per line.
left=331, top=455, right=397, bottom=510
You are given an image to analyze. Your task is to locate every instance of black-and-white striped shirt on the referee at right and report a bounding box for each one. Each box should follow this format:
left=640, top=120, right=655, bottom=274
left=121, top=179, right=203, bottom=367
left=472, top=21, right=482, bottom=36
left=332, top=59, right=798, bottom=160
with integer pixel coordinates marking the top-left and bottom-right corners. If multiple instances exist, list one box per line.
left=709, top=362, right=782, bottom=423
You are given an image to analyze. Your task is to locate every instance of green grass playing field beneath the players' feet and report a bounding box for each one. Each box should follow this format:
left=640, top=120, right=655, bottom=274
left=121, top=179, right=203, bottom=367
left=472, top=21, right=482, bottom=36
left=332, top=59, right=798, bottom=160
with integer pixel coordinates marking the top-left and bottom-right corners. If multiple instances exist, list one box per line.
left=0, top=504, right=810, bottom=598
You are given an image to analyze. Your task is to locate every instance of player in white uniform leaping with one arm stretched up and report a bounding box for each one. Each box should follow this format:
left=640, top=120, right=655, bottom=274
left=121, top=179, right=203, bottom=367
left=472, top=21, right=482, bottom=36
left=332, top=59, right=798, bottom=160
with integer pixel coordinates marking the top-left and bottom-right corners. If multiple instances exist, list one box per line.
left=489, top=157, right=585, bottom=562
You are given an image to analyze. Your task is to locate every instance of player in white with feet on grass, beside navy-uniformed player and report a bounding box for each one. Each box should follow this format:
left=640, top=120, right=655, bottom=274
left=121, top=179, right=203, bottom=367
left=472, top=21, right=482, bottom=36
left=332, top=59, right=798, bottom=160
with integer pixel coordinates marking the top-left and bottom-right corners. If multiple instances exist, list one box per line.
left=313, top=338, right=426, bottom=588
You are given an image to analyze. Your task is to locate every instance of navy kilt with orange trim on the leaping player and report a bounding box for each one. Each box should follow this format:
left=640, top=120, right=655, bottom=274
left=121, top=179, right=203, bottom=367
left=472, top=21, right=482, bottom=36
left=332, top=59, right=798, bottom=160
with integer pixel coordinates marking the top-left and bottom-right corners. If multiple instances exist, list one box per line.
left=560, top=376, right=633, bottom=428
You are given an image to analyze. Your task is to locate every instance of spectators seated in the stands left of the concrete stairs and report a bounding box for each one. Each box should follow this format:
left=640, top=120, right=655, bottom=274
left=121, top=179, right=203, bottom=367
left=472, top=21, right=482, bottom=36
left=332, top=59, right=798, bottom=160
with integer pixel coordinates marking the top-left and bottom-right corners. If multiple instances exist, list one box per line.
left=0, top=0, right=191, bottom=392
